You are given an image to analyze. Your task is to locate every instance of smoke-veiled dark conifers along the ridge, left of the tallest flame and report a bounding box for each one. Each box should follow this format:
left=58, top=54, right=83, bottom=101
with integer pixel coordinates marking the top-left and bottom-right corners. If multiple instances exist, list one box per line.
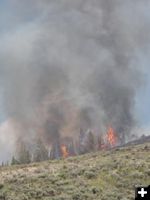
left=2, top=129, right=103, bottom=166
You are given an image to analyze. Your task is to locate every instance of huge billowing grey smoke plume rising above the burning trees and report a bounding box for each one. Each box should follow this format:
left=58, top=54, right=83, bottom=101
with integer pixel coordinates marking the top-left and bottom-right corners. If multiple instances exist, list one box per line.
left=0, top=0, right=150, bottom=161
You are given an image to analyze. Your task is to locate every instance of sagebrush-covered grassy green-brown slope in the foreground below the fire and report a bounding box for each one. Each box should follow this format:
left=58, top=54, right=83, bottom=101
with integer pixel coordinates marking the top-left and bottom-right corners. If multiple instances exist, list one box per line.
left=0, top=143, right=150, bottom=200
